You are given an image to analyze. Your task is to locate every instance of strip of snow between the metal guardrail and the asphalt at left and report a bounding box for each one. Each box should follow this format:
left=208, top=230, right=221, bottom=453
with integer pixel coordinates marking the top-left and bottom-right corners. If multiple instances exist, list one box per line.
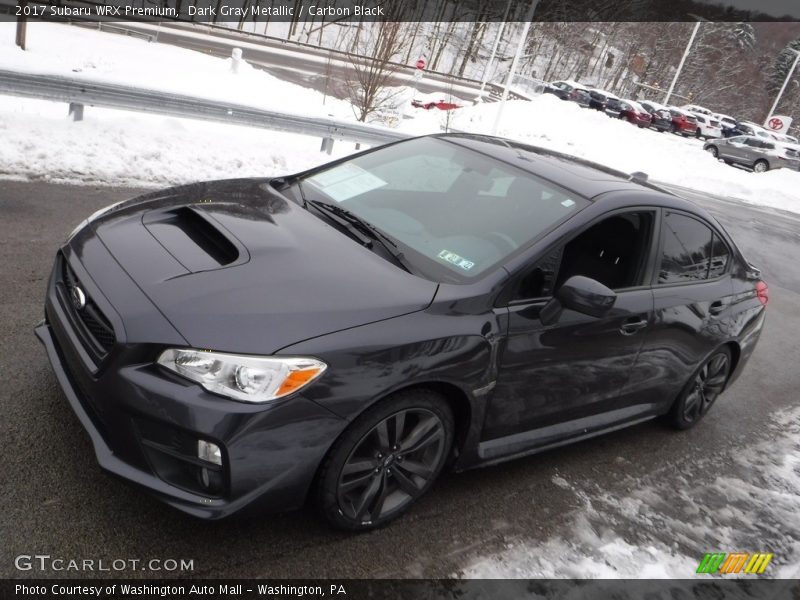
left=0, top=96, right=354, bottom=187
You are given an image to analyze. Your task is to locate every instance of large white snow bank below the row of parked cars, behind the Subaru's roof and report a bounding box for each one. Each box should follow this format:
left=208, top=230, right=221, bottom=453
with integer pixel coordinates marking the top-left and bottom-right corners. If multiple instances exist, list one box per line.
left=451, top=94, right=800, bottom=212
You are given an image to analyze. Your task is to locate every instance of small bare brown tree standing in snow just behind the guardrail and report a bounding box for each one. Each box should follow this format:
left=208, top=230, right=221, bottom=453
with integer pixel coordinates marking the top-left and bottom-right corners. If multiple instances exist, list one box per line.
left=346, top=20, right=410, bottom=121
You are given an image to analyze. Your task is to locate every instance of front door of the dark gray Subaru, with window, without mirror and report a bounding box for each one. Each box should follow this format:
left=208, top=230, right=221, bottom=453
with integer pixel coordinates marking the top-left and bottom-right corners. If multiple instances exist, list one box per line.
left=482, top=209, right=656, bottom=450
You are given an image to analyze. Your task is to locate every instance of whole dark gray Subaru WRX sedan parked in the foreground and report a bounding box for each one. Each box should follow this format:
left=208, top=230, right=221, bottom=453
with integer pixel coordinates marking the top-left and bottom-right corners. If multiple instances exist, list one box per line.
left=36, top=135, right=767, bottom=530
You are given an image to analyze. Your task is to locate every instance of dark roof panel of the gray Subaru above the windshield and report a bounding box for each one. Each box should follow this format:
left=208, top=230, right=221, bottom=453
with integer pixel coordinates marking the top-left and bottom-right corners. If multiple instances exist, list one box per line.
left=436, top=134, right=675, bottom=200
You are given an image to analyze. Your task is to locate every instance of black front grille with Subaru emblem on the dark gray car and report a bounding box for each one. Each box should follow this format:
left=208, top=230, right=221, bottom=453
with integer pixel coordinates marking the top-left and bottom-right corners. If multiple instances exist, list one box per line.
left=56, top=255, right=116, bottom=362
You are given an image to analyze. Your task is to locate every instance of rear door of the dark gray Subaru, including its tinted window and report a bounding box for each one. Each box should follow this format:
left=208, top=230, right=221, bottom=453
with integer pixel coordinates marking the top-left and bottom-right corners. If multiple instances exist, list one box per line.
left=625, top=210, right=733, bottom=410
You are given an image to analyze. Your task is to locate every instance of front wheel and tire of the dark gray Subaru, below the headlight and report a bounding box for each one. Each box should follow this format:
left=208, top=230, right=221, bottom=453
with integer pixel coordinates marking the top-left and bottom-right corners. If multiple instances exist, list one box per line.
left=316, top=389, right=455, bottom=531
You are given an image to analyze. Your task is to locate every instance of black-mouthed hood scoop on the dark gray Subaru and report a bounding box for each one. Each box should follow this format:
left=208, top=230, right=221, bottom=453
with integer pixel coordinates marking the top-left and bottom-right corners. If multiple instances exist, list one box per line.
left=142, top=206, right=249, bottom=273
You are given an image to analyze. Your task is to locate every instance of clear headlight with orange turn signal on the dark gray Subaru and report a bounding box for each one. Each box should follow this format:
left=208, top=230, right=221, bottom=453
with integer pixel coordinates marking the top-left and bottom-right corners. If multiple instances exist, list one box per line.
left=158, top=348, right=328, bottom=402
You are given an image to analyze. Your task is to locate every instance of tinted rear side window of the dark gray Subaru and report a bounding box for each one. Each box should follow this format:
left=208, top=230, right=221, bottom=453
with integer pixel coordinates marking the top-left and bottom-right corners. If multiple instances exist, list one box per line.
left=658, top=212, right=728, bottom=284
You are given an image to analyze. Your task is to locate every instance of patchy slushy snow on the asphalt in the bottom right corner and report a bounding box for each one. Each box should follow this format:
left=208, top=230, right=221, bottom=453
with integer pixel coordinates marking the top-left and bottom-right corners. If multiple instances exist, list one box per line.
left=462, top=408, right=800, bottom=579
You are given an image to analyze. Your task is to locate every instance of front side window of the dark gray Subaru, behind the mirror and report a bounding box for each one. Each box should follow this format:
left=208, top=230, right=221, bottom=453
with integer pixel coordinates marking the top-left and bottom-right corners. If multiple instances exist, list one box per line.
left=512, top=211, right=655, bottom=302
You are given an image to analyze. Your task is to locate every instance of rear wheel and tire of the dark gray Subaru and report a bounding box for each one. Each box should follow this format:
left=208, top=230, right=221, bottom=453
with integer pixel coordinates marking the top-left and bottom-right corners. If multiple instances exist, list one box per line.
left=668, top=346, right=732, bottom=429
